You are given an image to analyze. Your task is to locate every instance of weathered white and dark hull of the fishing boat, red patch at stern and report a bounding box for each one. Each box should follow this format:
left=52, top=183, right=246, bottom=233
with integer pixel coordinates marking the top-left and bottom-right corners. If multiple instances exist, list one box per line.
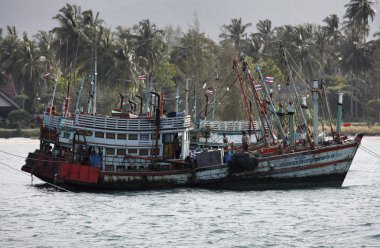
left=22, top=142, right=359, bottom=190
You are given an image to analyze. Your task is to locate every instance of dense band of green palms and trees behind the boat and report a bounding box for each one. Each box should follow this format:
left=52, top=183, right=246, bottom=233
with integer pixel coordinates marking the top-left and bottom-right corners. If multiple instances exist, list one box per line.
left=0, top=0, right=380, bottom=124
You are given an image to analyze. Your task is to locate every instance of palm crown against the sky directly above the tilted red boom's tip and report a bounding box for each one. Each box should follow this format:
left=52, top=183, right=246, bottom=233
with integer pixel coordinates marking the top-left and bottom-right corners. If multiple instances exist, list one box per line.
left=219, top=18, right=252, bottom=53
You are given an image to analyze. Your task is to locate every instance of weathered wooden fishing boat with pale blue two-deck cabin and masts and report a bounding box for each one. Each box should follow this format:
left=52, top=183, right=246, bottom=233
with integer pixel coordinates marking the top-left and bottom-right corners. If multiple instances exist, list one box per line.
left=22, top=49, right=363, bottom=190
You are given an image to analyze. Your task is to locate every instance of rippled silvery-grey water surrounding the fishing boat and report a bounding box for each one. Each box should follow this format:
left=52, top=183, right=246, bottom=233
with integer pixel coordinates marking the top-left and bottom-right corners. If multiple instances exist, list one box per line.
left=0, top=137, right=380, bottom=247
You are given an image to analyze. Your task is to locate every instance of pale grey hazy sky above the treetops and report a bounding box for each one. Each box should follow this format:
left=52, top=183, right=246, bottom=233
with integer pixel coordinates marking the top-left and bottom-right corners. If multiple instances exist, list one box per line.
left=0, top=0, right=380, bottom=41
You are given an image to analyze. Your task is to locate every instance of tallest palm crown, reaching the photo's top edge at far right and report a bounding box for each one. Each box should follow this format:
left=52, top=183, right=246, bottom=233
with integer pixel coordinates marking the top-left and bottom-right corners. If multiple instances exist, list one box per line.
left=344, top=0, right=376, bottom=42
